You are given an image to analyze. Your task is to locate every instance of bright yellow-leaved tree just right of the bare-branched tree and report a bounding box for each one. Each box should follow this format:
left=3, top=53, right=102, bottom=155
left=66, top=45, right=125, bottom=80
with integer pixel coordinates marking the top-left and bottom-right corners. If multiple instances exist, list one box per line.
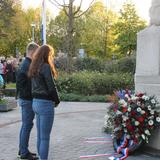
left=81, top=2, right=117, bottom=58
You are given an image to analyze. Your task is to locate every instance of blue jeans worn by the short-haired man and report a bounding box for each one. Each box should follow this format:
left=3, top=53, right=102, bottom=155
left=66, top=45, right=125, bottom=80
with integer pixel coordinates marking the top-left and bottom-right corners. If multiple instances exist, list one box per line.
left=19, top=99, right=35, bottom=156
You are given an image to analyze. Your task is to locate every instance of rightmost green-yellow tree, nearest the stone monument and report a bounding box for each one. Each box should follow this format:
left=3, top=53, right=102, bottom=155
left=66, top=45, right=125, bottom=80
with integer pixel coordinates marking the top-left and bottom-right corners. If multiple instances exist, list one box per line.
left=115, top=2, right=146, bottom=56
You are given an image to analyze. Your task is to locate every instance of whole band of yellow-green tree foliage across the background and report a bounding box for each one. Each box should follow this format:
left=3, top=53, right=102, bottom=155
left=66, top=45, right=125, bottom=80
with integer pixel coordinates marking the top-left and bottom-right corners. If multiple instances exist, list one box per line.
left=0, top=0, right=146, bottom=59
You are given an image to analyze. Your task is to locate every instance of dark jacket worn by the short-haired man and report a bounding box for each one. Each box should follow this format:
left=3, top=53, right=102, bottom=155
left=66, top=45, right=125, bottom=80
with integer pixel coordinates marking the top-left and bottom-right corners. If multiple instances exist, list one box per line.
left=16, top=57, right=32, bottom=100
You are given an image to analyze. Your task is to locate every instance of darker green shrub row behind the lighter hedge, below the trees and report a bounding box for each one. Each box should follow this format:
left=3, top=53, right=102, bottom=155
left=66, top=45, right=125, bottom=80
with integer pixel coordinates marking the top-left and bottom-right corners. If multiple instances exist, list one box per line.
left=56, top=56, right=136, bottom=73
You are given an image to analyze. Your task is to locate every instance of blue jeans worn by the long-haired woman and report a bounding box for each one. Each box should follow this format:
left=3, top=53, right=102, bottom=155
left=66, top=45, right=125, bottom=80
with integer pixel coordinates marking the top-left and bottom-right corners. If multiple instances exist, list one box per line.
left=33, top=99, right=54, bottom=160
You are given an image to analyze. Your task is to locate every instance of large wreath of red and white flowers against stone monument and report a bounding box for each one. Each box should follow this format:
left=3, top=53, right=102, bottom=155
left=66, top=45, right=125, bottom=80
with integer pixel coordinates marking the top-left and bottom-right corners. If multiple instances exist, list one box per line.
left=104, top=90, right=160, bottom=158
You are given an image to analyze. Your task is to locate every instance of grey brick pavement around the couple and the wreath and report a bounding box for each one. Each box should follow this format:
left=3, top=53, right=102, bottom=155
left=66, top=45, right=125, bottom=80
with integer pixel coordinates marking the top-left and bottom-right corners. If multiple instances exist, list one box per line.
left=0, top=102, right=160, bottom=160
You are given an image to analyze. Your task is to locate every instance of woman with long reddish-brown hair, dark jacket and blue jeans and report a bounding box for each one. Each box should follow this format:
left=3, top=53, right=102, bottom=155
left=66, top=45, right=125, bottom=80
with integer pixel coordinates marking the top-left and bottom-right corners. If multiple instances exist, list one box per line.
left=28, top=45, right=60, bottom=160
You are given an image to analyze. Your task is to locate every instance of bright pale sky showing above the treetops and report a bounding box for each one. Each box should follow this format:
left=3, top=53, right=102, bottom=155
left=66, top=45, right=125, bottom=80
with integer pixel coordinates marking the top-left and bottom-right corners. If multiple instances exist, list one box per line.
left=22, top=0, right=151, bottom=21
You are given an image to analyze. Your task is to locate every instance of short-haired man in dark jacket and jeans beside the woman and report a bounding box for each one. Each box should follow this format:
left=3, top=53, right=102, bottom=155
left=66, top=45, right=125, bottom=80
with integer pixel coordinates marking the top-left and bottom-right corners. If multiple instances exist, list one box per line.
left=16, top=42, right=39, bottom=160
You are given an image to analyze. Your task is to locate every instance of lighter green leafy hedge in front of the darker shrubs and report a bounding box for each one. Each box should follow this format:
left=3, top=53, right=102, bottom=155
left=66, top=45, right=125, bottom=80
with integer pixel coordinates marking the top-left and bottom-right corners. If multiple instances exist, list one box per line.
left=57, top=71, right=134, bottom=95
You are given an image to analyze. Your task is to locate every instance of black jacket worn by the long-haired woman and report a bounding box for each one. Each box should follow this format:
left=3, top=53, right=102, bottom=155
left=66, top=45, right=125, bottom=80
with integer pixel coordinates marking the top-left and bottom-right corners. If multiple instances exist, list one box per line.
left=32, top=63, right=60, bottom=105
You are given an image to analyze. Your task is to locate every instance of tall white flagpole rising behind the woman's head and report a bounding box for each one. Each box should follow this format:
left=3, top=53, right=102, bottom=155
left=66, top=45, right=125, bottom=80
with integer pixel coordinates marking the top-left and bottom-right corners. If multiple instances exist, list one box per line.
left=42, top=0, right=46, bottom=45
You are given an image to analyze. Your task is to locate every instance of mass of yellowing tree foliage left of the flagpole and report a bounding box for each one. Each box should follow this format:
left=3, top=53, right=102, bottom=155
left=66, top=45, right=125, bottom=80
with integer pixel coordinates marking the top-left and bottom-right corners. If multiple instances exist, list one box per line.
left=0, top=0, right=41, bottom=56
